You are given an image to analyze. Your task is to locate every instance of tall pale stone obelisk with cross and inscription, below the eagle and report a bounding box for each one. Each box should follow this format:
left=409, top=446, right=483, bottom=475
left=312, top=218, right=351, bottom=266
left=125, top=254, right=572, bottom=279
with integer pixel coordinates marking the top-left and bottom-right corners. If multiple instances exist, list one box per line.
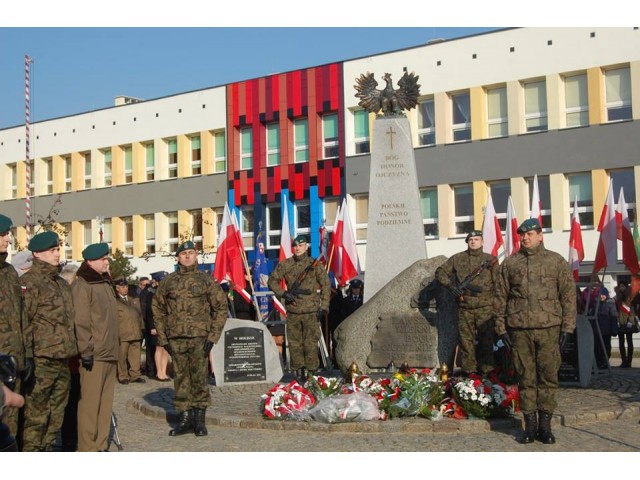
left=364, top=116, right=427, bottom=302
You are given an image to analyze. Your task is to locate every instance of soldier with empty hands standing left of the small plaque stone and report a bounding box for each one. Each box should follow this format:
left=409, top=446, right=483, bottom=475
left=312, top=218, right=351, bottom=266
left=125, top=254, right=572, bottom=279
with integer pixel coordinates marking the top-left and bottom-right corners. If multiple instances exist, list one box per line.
left=151, top=241, right=227, bottom=436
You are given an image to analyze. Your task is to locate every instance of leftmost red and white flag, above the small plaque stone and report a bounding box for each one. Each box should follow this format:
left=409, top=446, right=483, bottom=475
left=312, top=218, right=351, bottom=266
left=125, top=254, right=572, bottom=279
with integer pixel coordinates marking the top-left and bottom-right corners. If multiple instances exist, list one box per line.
left=213, top=203, right=251, bottom=303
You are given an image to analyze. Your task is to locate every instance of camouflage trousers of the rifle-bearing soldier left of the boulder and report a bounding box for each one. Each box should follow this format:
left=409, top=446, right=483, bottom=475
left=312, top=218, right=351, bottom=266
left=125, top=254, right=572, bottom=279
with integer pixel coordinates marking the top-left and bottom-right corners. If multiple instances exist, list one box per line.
left=287, top=312, right=320, bottom=370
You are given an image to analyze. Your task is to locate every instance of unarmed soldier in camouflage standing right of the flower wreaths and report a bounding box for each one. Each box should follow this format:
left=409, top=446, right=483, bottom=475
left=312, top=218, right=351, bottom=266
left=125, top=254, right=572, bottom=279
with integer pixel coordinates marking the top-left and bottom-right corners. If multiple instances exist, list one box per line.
left=494, top=218, right=576, bottom=444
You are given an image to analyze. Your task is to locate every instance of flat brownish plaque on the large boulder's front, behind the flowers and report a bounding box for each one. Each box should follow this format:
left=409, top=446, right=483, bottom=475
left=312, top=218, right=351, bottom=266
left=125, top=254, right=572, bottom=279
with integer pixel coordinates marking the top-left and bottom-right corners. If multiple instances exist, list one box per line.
left=367, top=313, right=439, bottom=368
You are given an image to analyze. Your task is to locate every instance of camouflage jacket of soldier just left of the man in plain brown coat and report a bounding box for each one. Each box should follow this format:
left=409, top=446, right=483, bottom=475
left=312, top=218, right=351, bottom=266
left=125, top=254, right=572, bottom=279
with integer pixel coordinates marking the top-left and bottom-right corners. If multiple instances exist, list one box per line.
left=20, top=258, right=78, bottom=359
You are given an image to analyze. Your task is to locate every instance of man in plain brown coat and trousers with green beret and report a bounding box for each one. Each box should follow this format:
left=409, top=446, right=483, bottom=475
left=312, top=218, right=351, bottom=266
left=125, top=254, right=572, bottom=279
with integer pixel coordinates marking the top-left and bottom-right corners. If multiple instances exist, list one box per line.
left=71, top=243, right=118, bottom=452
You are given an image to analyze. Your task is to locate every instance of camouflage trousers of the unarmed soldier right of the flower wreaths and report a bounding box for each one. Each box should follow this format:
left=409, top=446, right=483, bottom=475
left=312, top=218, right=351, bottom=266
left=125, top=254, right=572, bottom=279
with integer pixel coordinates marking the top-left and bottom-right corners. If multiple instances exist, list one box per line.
left=509, top=326, right=560, bottom=414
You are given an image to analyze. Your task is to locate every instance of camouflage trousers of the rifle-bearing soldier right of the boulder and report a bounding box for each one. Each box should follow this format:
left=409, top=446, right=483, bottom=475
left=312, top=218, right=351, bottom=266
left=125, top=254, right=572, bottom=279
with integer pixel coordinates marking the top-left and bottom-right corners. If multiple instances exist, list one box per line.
left=458, top=307, right=495, bottom=373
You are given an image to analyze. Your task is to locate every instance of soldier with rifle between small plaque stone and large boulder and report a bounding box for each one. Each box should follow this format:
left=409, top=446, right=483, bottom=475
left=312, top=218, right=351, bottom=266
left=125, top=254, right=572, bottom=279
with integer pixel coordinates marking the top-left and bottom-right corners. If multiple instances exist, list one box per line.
left=268, top=235, right=331, bottom=381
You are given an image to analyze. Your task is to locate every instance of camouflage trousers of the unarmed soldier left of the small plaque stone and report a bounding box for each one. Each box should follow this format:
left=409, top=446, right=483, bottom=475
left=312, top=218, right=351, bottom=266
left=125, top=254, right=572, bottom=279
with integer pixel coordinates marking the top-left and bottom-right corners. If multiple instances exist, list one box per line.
left=169, top=337, right=211, bottom=412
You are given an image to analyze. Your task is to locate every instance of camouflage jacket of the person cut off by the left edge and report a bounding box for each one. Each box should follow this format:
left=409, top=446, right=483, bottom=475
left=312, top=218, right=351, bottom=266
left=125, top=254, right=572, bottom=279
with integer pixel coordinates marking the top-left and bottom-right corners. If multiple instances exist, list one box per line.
left=0, top=252, right=25, bottom=370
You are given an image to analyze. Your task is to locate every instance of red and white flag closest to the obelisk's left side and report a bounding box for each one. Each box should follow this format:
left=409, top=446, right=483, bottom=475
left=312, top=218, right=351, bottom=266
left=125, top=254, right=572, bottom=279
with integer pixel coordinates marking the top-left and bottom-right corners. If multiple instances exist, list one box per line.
left=330, top=198, right=359, bottom=285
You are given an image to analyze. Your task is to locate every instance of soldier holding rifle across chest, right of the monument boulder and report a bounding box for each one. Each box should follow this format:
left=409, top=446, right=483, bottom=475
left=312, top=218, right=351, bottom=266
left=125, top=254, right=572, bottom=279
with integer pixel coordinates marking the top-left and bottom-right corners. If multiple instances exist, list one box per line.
left=435, top=230, right=498, bottom=375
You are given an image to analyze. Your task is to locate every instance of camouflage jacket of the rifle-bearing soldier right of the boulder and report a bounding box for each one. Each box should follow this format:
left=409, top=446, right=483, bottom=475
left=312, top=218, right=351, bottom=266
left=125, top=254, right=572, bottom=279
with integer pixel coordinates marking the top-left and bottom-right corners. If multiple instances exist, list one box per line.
left=435, top=248, right=499, bottom=309
